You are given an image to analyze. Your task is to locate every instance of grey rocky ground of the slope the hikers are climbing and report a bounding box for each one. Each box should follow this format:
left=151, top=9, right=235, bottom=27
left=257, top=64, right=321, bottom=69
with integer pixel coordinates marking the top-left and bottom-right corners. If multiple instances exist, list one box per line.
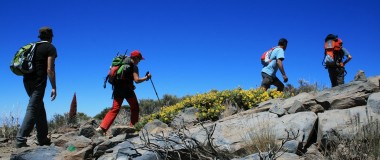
left=0, top=73, right=380, bottom=160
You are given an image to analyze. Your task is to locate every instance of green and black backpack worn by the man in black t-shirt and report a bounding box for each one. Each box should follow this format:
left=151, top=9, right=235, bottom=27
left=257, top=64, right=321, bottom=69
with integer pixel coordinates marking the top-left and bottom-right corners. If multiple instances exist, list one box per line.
left=10, top=41, right=47, bottom=76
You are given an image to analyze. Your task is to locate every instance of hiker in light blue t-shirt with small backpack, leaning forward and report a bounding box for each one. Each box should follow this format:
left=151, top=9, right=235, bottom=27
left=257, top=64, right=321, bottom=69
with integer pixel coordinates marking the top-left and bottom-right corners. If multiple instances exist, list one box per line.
left=261, top=38, right=288, bottom=91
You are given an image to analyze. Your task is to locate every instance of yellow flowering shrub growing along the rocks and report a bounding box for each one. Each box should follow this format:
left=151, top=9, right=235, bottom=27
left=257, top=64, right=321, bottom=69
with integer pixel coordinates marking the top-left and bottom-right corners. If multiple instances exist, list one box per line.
left=136, top=88, right=284, bottom=128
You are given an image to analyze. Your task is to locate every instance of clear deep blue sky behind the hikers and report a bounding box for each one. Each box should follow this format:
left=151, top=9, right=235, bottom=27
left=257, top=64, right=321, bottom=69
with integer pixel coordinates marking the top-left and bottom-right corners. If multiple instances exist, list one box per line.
left=0, top=0, right=380, bottom=119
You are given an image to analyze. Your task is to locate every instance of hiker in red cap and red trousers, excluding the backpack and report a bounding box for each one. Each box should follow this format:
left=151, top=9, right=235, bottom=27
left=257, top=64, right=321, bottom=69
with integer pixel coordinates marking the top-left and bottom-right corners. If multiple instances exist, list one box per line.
left=96, top=50, right=151, bottom=133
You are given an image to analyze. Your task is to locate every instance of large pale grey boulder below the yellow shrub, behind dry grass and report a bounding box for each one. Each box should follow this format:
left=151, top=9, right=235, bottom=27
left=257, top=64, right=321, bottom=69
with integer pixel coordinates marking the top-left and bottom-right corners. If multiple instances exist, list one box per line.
left=190, top=112, right=317, bottom=153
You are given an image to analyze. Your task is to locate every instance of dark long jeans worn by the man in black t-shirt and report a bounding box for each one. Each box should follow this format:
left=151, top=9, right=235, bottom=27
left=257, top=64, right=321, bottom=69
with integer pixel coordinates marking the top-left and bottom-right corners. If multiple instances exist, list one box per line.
left=16, top=80, right=48, bottom=144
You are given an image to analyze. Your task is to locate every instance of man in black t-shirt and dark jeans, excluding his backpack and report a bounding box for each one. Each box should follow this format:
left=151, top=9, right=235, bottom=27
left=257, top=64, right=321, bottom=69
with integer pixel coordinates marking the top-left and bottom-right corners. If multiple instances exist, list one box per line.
left=16, top=27, right=57, bottom=148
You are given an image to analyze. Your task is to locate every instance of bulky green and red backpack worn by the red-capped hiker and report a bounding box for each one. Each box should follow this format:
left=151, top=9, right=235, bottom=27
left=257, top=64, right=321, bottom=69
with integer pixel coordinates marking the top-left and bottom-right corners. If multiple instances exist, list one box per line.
left=103, top=55, right=133, bottom=88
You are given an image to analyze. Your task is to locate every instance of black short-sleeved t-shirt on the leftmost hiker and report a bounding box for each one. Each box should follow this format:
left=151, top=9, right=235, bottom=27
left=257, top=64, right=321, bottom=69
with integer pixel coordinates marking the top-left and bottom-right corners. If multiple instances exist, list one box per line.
left=24, top=42, right=57, bottom=83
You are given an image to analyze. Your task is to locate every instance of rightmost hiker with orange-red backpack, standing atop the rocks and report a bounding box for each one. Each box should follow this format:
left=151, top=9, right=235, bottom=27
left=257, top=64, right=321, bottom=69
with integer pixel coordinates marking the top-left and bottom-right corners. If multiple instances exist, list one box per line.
left=322, top=34, right=352, bottom=87
